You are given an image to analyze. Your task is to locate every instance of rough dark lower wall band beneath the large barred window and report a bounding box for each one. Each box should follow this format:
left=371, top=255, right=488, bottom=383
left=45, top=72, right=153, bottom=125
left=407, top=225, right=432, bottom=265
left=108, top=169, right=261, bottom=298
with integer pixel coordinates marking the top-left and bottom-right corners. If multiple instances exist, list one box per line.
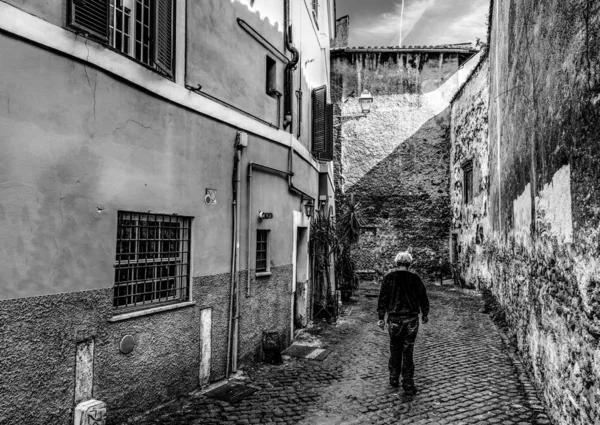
left=0, top=286, right=200, bottom=425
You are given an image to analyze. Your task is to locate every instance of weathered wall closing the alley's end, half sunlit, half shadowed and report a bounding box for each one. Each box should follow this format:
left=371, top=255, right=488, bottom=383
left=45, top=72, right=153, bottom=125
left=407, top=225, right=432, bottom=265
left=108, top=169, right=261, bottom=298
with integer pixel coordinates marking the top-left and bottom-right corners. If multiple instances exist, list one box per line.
left=332, top=48, right=474, bottom=275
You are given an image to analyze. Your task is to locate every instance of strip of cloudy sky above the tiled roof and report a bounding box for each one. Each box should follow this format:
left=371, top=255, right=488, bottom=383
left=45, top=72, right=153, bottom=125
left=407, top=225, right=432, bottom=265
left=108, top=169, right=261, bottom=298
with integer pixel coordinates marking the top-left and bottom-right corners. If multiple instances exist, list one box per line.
left=336, top=0, right=490, bottom=46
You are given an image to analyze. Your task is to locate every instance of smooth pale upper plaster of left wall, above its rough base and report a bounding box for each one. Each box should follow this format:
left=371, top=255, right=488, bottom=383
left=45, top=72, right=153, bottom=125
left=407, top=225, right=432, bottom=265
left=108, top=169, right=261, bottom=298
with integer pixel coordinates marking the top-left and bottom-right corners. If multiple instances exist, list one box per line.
left=0, top=35, right=318, bottom=298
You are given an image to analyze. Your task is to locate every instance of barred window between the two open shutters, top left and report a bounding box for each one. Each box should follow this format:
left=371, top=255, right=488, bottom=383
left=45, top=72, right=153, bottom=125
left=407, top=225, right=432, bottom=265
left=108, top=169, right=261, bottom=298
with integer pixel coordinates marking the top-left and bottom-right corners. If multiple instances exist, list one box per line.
left=110, top=0, right=154, bottom=65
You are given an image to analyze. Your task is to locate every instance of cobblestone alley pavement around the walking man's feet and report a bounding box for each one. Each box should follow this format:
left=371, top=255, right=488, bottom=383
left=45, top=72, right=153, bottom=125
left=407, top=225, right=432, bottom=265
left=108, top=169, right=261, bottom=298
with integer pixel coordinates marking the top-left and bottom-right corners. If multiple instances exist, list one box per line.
left=129, top=285, right=551, bottom=425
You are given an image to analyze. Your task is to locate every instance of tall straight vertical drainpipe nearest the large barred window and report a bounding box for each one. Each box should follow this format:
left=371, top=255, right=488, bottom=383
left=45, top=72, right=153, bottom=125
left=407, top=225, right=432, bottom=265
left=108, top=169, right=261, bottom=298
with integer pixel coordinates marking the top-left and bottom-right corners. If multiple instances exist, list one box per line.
left=225, top=135, right=245, bottom=377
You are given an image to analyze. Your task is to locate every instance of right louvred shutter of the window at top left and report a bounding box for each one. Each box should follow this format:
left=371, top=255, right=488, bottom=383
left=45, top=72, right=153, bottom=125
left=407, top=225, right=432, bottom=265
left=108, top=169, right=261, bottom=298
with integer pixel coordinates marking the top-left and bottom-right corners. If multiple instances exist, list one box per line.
left=153, top=0, right=174, bottom=77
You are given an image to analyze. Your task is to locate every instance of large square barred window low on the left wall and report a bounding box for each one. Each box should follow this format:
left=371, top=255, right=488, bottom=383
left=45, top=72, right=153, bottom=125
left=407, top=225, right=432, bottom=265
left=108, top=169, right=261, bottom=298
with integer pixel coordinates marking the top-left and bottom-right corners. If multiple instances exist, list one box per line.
left=113, top=211, right=191, bottom=308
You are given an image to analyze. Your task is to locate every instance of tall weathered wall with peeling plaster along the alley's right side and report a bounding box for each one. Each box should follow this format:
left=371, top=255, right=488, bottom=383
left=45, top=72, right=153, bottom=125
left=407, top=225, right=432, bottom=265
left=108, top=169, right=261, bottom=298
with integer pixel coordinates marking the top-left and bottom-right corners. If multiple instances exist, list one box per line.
left=457, top=0, right=600, bottom=424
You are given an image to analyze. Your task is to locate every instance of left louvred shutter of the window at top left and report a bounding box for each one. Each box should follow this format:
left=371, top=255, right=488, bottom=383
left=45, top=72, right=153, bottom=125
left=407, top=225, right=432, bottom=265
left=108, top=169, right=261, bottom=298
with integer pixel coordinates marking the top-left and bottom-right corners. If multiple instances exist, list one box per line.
left=69, top=0, right=109, bottom=41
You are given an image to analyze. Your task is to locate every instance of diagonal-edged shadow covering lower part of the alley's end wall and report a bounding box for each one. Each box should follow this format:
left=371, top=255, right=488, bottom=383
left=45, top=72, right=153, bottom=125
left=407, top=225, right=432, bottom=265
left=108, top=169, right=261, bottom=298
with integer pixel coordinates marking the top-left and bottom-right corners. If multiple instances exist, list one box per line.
left=347, top=108, right=452, bottom=276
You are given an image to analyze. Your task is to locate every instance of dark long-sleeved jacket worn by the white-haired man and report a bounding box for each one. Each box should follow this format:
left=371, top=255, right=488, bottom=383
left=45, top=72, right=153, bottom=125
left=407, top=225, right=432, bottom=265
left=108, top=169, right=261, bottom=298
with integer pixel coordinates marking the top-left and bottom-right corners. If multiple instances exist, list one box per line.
left=377, top=270, right=429, bottom=320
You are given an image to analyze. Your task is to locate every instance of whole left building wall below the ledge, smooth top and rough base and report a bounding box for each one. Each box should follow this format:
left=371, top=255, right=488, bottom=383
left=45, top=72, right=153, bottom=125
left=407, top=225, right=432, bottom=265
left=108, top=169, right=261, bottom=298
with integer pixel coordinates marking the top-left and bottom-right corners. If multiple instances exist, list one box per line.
left=0, top=28, right=319, bottom=424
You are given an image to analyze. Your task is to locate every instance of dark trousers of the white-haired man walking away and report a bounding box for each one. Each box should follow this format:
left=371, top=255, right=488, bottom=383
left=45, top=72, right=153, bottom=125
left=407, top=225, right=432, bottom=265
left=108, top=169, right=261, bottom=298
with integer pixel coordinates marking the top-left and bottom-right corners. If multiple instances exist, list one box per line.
left=388, top=317, right=419, bottom=389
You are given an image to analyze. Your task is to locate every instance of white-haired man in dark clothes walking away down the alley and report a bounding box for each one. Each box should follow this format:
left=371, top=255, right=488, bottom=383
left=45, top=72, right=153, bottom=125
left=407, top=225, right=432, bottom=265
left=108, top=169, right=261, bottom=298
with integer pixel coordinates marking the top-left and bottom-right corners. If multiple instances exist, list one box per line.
left=377, top=251, right=429, bottom=395
